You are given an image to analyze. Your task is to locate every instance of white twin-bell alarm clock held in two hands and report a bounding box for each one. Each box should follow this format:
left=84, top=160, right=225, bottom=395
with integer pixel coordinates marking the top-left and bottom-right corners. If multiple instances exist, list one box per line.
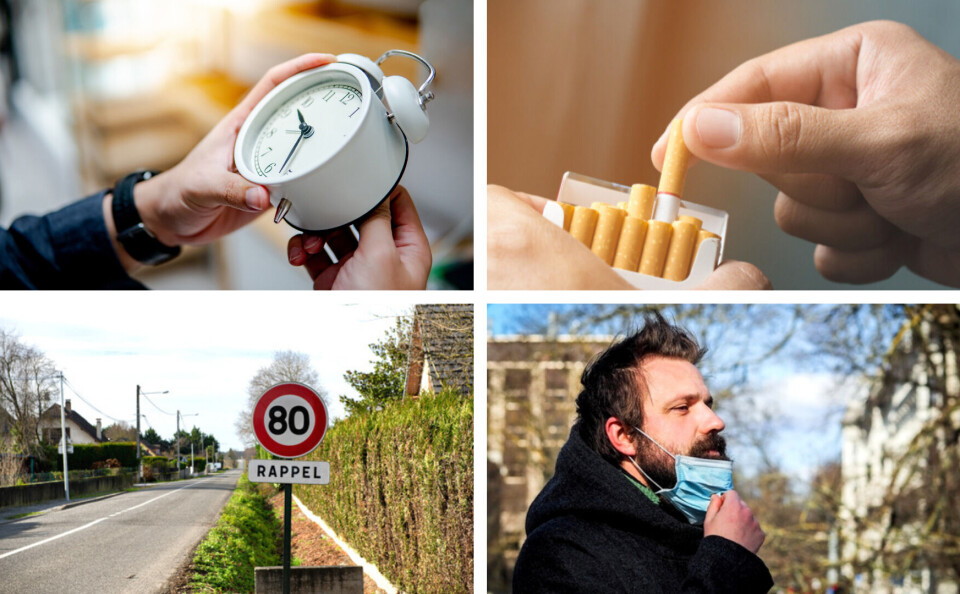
left=233, top=50, right=436, bottom=231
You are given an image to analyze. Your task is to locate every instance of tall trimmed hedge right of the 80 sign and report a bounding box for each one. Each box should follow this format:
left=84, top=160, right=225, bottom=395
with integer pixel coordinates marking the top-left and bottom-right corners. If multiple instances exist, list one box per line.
left=294, top=393, right=473, bottom=593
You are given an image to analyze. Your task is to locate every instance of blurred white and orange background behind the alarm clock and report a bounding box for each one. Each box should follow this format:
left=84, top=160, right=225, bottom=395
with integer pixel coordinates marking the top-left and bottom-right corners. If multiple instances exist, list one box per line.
left=0, top=0, right=473, bottom=289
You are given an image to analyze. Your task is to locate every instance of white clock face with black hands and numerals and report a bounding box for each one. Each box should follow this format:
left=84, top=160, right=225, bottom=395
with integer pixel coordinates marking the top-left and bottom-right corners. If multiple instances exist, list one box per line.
left=253, top=78, right=364, bottom=181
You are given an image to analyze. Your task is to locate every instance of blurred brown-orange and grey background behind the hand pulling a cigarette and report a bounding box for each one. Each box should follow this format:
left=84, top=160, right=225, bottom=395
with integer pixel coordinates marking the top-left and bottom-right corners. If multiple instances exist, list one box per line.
left=487, top=0, right=960, bottom=289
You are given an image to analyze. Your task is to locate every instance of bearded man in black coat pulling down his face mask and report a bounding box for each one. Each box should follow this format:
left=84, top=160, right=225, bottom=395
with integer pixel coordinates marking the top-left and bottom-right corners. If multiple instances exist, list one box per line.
left=513, top=314, right=773, bottom=594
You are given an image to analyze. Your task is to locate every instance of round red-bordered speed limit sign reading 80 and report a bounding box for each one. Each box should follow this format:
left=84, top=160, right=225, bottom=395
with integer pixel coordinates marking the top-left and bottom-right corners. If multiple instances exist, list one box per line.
left=253, top=382, right=327, bottom=458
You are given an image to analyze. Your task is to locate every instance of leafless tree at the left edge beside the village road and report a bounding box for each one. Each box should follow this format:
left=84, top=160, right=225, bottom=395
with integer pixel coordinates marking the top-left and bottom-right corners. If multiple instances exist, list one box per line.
left=0, top=328, right=56, bottom=454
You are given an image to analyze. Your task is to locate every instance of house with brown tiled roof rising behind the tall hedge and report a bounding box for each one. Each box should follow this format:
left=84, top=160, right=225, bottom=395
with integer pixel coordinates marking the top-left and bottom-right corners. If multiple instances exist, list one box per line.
left=405, top=304, right=473, bottom=396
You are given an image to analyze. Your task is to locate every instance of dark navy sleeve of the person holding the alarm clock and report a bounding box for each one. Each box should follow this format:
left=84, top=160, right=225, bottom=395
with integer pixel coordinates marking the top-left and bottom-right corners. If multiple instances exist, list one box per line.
left=0, top=190, right=145, bottom=289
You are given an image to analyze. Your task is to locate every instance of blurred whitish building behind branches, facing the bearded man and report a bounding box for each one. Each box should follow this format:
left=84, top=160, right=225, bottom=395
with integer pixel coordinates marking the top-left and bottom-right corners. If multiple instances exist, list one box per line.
left=840, top=305, right=960, bottom=594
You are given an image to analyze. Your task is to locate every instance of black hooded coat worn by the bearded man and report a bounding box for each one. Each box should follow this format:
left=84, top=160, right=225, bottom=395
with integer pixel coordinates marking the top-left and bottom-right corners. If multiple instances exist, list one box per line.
left=513, top=426, right=773, bottom=594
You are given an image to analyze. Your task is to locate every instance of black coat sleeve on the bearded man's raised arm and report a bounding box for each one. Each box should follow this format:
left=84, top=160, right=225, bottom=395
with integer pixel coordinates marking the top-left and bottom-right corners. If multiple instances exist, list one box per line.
left=682, top=536, right=773, bottom=594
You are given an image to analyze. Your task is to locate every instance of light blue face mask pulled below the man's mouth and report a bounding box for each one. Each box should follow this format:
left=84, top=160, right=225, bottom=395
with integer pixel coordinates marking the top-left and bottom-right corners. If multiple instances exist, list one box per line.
left=628, top=427, right=733, bottom=524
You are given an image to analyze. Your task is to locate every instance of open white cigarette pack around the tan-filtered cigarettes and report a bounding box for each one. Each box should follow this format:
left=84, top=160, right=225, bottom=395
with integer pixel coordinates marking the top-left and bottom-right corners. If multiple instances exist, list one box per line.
left=543, top=171, right=728, bottom=290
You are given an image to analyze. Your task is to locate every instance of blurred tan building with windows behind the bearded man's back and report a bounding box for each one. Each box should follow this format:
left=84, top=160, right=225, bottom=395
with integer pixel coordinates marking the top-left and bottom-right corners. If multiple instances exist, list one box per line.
left=487, top=335, right=613, bottom=591
